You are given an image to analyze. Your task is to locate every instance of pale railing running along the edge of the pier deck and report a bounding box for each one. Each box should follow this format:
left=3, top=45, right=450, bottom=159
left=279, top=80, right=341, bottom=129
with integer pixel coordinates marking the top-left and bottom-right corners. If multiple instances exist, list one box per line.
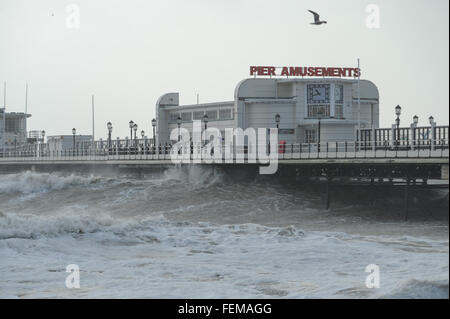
left=0, top=136, right=449, bottom=162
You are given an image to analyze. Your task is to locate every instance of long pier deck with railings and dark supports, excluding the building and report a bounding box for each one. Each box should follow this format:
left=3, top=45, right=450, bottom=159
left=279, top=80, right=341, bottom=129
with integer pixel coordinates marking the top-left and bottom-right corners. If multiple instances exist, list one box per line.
left=0, top=127, right=449, bottom=220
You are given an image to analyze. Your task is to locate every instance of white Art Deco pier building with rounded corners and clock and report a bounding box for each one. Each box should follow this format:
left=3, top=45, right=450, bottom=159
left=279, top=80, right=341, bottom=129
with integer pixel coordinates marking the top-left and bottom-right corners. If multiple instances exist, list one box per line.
left=156, top=77, right=379, bottom=144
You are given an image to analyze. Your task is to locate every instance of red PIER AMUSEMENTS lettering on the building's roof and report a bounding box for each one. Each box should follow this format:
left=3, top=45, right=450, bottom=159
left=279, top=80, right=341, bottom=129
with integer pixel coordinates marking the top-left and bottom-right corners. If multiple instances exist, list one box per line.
left=250, top=66, right=361, bottom=77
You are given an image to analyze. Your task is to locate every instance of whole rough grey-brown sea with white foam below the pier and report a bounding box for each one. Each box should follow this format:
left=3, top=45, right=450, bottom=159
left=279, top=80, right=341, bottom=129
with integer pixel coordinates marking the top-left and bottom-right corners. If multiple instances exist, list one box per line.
left=0, top=171, right=449, bottom=298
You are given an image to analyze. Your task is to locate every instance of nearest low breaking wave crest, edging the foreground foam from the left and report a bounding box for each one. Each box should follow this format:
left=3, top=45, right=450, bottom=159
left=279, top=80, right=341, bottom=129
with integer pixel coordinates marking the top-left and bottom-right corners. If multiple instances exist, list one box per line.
left=0, top=212, right=305, bottom=241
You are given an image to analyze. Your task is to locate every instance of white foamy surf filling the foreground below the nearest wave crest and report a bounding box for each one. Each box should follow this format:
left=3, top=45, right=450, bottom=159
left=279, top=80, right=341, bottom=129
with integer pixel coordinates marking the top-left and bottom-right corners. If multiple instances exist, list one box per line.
left=0, top=214, right=448, bottom=298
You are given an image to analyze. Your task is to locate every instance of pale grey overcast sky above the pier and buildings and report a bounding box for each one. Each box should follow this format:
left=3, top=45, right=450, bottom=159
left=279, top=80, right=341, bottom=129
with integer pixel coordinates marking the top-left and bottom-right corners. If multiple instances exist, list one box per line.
left=0, top=0, right=449, bottom=137
